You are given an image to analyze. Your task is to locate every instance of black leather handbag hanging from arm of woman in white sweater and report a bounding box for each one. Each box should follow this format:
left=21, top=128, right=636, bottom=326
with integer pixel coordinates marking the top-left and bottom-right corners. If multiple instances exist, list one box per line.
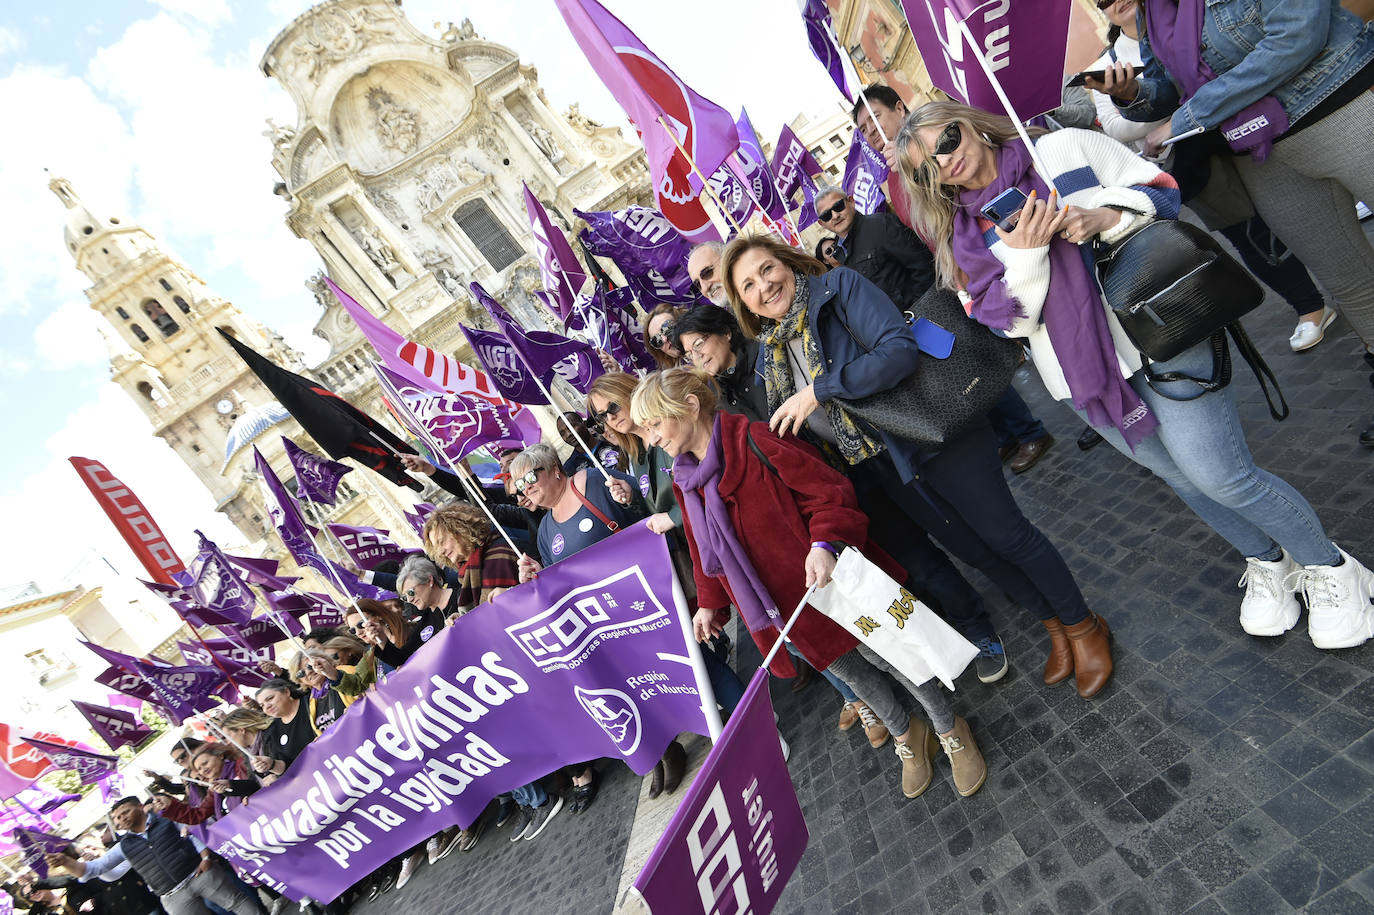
left=1094, top=220, right=1289, bottom=419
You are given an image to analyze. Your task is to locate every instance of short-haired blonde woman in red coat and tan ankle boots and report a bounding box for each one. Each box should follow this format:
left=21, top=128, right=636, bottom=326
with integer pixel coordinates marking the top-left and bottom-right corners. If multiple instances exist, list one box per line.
left=631, top=368, right=988, bottom=797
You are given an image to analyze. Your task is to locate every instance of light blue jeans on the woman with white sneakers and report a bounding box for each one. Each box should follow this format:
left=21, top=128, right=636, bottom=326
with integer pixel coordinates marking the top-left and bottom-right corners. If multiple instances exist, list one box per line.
left=1077, top=335, right=1341, bottom=566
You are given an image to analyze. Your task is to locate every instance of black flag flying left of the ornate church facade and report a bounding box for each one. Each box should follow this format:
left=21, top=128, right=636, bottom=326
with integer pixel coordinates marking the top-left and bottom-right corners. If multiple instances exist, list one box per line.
left=217, top=328, right=423, bottom=490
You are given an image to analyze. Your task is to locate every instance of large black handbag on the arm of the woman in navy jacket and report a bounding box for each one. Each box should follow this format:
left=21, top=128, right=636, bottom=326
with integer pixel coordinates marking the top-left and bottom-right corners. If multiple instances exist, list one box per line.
left=840, top=286, right=1025, bottom=451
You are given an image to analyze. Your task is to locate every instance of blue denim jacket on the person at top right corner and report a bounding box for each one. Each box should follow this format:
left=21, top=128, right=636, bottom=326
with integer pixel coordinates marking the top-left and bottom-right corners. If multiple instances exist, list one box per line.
left=1118, top=0, right=1374, bottom=136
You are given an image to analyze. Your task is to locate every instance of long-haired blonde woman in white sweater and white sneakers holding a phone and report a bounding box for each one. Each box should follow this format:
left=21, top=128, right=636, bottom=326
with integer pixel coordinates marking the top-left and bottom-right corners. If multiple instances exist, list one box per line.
left=896, top=102, right=1374, bottom=648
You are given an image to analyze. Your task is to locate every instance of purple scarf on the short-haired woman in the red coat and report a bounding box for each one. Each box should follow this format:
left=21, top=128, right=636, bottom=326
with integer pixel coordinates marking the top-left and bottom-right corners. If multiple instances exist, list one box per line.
left=673, top=414, right=783, bottom=632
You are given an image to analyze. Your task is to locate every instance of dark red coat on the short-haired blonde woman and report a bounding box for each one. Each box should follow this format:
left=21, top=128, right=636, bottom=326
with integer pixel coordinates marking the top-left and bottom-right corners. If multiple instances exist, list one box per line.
left=673, top=414, right=907, bottom=676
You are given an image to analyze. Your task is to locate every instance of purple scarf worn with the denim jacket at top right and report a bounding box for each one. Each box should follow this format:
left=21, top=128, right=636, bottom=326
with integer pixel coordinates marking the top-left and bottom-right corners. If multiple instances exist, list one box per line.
left=1145, top=0, right=1289, bottom=162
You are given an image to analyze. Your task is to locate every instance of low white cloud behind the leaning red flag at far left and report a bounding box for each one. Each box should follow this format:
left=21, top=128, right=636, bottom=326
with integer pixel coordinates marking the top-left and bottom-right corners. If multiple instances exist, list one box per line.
left=0, top=383, right=243, bottom=587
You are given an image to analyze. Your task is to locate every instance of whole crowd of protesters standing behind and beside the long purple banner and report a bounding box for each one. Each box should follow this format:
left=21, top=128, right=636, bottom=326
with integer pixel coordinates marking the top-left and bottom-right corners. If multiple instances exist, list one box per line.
left=14, top=0, right=1374, bottom=914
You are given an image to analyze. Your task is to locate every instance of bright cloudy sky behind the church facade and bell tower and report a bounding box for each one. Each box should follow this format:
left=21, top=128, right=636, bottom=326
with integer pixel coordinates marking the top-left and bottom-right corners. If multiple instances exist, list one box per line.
left=0, top=0, right=841, bottom=588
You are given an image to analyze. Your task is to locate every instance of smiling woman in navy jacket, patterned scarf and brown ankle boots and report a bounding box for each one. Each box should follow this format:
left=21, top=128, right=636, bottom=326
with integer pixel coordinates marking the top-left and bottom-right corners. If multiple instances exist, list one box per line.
left=721, top=236, right=1112, bottom=698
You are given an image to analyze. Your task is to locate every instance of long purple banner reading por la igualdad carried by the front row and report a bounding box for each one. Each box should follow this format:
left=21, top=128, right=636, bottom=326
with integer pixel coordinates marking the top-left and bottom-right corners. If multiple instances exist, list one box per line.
left=209, top=523, right=719, bottom=903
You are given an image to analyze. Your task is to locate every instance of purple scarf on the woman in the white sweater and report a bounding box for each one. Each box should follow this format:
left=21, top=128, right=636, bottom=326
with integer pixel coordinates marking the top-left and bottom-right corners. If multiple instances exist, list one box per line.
left=954, top=140, right=1160, bottom=451
